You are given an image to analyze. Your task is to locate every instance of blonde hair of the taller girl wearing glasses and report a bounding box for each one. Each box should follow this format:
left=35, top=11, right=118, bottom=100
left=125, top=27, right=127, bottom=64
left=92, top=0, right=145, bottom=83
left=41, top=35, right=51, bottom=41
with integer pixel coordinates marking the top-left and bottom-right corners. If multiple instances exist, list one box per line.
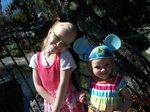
left=41, top=22, right=77, bottom=50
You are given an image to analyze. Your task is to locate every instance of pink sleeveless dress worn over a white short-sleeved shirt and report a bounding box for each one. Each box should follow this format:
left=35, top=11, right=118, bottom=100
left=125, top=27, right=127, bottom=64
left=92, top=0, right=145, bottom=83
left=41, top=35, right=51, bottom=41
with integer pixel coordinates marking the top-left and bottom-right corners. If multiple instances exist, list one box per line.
left=37, top=52, right=84, bottom=112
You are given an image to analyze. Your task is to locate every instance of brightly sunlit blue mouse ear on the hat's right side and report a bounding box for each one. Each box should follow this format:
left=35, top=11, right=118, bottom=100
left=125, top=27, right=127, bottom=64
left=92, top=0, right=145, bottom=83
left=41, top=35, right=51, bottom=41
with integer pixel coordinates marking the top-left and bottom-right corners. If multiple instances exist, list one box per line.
left=103, top=34, right=121, bottom=51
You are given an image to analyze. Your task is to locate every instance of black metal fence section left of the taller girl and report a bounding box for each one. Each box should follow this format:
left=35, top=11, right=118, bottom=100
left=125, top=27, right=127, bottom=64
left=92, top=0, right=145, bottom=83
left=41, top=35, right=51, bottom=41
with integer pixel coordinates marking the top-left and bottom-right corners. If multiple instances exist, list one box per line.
left=0, top=29, right=42, bottom=112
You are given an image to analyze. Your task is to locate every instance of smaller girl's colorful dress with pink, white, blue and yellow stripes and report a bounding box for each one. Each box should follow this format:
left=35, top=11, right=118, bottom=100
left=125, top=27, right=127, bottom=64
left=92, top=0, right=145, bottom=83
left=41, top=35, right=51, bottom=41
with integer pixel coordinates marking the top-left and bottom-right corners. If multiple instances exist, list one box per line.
left=88, top=76, right=126, bottom=112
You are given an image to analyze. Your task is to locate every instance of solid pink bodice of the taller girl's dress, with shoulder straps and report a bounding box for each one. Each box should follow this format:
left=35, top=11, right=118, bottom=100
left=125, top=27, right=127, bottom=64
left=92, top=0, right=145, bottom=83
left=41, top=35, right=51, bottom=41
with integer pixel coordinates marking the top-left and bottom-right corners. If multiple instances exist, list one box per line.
left=37, top=52, right=60, bottom=91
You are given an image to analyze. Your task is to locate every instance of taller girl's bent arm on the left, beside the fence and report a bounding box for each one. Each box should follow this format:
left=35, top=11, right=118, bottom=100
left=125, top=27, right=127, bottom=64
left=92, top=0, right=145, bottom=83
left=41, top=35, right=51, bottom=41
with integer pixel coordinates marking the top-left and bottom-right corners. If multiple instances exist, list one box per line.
left=32, top=69, right=54, bottom=105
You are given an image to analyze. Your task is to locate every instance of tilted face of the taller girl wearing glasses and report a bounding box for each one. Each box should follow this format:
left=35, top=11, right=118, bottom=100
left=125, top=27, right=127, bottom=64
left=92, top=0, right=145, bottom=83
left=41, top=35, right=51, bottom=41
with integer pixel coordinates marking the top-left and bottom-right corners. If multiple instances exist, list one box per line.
left=48, top=28, right=75, bottom=53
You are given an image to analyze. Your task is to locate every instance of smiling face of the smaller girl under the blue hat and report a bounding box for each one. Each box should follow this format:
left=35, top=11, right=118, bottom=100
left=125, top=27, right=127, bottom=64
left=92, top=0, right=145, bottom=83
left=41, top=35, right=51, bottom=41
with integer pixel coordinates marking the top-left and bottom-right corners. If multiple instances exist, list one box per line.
left=90, top=58, right=112, bottom=80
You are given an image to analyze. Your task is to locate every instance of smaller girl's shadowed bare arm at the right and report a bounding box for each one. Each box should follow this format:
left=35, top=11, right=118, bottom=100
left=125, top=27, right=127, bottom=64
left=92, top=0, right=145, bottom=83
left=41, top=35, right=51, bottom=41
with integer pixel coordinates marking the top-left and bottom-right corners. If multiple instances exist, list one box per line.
left=120, top=87, right=133, bottom=112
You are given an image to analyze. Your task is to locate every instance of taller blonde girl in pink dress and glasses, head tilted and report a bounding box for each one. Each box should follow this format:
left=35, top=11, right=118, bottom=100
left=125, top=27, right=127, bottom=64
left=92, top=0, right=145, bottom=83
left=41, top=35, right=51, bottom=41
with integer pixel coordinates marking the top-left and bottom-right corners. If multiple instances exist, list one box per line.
left=29, top=22, right=83, bottom=112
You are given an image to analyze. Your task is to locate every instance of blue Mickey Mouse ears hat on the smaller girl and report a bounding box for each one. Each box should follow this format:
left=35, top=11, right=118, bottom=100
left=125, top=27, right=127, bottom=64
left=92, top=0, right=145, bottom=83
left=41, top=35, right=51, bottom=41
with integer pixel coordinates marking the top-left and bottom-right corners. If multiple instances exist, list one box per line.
left=73, top=34, right=121, bottom=61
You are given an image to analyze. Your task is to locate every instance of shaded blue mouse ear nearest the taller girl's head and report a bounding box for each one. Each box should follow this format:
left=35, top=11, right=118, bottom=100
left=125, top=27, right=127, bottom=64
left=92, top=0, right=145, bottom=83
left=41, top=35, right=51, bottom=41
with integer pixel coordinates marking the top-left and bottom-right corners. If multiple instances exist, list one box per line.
left=73, top=38, right=90, bottom=54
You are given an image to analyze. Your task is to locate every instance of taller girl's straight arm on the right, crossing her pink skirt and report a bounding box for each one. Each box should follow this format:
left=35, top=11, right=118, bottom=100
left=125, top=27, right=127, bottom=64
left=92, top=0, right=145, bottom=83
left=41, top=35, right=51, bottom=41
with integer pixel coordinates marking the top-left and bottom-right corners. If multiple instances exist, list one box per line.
left=53, top=69, right=72, bottom=112
